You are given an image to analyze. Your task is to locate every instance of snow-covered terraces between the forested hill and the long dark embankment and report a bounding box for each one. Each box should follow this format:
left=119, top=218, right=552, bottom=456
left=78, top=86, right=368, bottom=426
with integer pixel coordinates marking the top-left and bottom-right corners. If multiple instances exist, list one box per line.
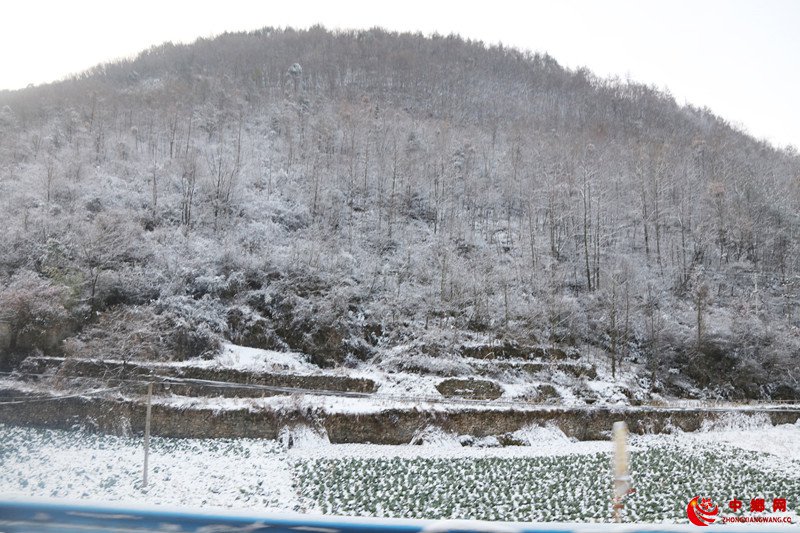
left=134, top=344, right=796, bottom=413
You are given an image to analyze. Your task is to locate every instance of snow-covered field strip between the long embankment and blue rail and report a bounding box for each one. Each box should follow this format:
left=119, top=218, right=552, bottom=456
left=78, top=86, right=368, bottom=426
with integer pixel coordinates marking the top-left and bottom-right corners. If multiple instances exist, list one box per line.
left=0, top=418, right=800, bottom=520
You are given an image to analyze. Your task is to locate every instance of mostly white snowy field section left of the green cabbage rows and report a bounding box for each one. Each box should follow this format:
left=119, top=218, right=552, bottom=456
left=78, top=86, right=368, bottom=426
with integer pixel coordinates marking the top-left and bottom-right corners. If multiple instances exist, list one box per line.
left=0, top=425, right=297, bottom=509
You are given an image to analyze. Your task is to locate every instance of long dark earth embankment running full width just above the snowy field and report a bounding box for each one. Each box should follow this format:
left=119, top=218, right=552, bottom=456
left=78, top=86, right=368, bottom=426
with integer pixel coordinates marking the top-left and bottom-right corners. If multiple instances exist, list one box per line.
left=0, top=390, right=800, bottom=444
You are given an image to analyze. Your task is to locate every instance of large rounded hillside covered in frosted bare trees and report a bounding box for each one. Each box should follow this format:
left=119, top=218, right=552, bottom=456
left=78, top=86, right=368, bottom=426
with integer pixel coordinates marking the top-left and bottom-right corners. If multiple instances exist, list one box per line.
left=0, top=27, right=800, bottom=399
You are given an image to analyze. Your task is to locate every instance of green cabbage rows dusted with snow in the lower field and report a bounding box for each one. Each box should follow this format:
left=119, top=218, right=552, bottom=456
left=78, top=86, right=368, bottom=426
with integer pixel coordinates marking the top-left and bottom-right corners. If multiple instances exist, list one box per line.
left=297, top=444, right=800, bottom=522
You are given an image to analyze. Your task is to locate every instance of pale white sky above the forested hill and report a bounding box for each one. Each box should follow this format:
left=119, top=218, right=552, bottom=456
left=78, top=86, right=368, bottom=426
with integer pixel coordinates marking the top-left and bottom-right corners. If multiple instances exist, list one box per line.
left=0, top=0, right=800, bottom=148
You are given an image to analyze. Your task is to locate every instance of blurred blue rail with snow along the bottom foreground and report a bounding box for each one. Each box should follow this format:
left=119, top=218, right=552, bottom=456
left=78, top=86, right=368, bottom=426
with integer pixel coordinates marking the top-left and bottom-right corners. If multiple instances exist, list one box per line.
left=0, top=500, right=798, bottom=533
